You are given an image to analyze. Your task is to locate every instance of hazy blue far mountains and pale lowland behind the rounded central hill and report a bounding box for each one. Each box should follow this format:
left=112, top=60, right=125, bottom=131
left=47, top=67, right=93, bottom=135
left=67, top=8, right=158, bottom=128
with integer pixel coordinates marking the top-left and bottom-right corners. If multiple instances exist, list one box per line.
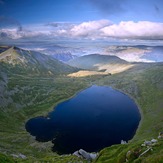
left=35, top=43, right=163, bottom=62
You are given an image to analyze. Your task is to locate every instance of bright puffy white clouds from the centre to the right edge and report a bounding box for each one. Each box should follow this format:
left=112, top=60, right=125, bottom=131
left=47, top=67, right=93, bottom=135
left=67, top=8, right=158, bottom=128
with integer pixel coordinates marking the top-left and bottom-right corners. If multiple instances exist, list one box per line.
left=70, top=20, right=163, bottom=39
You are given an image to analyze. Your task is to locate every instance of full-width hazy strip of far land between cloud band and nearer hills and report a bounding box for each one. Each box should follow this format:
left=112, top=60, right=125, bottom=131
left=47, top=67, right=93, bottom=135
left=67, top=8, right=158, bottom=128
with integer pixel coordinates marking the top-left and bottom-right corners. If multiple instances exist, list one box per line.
left=4, top=41, right=163, bottom=62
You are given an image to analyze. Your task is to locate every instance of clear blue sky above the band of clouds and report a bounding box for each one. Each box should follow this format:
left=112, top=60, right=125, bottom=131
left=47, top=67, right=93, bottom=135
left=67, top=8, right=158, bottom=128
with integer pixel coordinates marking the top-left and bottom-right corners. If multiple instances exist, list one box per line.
left=0, top=0, right=163, bottom=24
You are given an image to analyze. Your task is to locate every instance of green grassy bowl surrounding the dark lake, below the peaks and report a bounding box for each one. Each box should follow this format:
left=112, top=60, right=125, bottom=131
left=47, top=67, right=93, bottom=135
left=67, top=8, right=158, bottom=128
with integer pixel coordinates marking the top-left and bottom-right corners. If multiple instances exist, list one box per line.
left=0, top=47, right=163, bottom=163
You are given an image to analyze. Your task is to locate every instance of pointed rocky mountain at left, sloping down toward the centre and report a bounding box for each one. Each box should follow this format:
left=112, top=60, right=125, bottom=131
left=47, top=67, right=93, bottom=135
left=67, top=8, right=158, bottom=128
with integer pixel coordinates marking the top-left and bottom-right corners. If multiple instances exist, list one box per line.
left=0, top=46, right=77, bottom=76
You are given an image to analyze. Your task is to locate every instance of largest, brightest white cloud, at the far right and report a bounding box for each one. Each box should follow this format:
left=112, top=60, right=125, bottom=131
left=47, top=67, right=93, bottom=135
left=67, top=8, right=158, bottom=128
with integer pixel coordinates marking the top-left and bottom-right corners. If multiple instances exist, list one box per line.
left=101, top=21, right=163, bottom=39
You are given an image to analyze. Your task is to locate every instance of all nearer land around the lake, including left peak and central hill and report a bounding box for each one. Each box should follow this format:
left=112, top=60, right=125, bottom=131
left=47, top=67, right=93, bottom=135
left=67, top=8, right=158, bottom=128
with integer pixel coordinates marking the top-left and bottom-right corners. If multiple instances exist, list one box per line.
left=0, top=47, right=163, bottom=163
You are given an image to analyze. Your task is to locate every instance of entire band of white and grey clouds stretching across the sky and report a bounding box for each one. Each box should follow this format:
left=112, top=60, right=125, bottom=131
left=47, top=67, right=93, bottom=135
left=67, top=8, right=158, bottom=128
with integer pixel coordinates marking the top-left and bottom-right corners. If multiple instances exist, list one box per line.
left=0, top=20, right=163, bottom=40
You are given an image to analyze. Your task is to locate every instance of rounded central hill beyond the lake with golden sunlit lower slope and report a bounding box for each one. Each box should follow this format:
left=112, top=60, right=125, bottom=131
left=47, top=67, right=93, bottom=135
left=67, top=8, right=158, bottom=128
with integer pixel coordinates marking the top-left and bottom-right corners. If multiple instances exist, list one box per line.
left=68, top=54, right=134, bottom=77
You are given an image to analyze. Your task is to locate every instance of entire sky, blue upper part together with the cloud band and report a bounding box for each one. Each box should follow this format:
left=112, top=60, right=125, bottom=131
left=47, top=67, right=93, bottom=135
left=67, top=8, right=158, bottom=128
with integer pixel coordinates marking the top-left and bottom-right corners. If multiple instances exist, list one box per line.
left=0, top=0, right=163, bottom=41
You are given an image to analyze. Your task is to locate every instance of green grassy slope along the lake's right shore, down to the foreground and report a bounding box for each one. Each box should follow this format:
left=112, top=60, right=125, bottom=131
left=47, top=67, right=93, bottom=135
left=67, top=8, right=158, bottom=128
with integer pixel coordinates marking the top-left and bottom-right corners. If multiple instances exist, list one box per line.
left=93, top=63, right=163, bottom=163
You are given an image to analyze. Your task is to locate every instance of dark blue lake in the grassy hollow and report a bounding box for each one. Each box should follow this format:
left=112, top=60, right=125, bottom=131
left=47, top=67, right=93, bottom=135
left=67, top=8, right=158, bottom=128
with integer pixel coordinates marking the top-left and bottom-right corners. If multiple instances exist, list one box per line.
left=25, top=86, right=140, bottom=154
